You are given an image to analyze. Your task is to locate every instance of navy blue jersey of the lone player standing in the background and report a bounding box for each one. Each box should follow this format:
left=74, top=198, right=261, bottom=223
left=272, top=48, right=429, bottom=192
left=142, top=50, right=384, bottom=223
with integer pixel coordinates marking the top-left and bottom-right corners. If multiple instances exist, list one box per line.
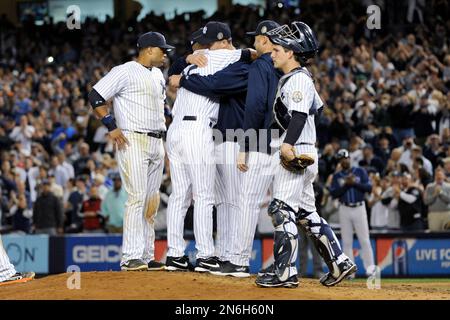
left=330, top=167, right=372, bottom=204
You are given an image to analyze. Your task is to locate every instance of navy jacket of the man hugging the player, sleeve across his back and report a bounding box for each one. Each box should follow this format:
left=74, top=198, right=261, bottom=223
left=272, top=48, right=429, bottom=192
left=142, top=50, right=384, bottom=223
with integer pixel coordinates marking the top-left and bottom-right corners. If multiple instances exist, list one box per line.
left=180, top=61, right=249, bottom=139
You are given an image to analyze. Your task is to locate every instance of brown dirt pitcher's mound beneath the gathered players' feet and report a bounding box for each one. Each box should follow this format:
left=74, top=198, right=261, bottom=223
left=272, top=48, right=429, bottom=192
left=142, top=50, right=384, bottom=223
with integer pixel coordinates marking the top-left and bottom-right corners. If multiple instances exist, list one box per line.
left=0, top=271, right=450, bottom=300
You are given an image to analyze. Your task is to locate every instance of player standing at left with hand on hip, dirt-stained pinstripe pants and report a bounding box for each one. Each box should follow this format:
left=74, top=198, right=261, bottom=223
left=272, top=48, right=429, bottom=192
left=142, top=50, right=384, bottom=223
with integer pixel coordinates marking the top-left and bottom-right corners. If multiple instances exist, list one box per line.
left=89, top=32, right=174, bottom=271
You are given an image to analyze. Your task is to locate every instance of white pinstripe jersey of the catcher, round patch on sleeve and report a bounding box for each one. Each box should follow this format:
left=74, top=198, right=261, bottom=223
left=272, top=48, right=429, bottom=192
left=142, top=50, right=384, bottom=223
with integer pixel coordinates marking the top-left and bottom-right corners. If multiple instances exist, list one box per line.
left=279, top=68, right=323, bottom=144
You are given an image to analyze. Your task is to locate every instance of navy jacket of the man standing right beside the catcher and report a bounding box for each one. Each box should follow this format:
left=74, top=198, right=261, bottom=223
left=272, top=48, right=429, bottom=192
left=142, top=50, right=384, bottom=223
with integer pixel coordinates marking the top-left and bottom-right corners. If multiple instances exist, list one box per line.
left=241, top=53, right=282, bottom=153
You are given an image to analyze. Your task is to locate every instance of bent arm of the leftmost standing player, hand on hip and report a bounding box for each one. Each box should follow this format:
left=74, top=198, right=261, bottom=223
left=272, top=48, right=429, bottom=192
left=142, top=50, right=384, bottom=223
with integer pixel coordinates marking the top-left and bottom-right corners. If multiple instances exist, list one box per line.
left=88, top=67, right=129, bottom=149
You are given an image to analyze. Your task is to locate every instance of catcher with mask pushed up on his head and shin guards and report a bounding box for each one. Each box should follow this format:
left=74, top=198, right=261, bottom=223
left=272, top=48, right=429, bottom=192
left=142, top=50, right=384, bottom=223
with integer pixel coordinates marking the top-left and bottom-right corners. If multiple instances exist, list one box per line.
left=256, top=22, right=356, bottom=288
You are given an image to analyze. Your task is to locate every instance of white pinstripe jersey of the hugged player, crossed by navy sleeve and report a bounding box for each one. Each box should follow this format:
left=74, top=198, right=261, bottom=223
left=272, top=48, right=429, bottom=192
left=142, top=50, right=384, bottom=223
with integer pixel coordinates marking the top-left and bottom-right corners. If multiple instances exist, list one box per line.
left=172, top=49, right=242, bottom=124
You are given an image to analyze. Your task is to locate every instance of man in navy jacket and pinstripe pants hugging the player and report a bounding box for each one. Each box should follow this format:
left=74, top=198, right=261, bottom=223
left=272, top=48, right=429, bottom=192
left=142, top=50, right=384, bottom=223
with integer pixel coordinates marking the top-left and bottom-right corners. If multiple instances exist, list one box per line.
left=173, top=57, right=250, bottom=276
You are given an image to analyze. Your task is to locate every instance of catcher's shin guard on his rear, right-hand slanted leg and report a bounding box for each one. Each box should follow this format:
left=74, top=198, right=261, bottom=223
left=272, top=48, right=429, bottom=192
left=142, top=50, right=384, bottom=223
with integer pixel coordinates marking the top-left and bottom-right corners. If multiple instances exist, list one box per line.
left=297, top=209, right=342, bottom=278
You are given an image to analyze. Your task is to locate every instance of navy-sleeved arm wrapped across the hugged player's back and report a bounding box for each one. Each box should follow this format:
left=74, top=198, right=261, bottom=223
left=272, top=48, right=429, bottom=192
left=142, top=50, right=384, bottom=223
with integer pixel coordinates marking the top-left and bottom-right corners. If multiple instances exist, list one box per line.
left=180, top=62, right=248, bottom=98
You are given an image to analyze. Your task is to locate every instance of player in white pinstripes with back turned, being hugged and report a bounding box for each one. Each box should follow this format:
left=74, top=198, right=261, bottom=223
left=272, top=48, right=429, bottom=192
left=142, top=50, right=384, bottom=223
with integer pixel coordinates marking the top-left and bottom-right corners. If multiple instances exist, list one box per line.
left=166, top=21, right=250, bottom=272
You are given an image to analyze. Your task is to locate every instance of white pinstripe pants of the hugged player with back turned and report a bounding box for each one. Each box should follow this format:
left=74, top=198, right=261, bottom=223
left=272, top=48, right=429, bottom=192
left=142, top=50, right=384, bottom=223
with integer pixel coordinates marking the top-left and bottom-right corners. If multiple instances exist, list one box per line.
left=167, top=119, right=216, bottom=258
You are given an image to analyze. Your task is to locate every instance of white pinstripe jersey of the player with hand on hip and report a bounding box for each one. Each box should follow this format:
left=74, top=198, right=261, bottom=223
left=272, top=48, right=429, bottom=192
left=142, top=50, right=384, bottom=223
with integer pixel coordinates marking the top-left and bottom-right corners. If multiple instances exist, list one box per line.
left=94, top=61, right=166, bottom=132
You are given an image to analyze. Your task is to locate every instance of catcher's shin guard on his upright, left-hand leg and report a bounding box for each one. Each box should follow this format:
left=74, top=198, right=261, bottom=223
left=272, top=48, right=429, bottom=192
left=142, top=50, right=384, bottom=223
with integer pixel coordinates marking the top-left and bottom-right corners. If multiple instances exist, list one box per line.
left=269, top=199, right=298, bottom=281
